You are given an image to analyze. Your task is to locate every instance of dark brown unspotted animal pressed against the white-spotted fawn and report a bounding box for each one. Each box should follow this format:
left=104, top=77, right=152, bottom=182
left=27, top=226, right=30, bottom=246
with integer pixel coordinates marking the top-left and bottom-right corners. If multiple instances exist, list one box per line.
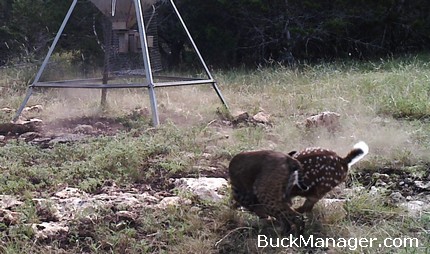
left=229, top=150, right=306, bottom=233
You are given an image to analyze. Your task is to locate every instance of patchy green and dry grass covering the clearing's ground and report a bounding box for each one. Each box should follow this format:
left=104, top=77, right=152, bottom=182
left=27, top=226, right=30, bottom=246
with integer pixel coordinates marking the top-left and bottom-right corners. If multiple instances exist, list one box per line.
left=0, top=55, right=430, bottom=253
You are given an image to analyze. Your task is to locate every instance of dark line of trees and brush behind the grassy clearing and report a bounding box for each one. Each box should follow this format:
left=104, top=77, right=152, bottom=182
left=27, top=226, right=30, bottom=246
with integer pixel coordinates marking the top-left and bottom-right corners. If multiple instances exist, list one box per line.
left=0, top=0, right=430, bottom=67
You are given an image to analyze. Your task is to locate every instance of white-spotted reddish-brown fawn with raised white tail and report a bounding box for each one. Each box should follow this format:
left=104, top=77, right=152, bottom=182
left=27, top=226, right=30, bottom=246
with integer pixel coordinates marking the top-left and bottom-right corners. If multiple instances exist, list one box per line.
left=289, top=141, right=369, bottom=213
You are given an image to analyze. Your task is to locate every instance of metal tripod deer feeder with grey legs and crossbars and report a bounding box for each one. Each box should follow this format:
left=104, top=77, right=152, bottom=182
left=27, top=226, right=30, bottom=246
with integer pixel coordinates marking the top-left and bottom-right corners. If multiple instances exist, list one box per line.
left=13, top=0, right=228, bottom=126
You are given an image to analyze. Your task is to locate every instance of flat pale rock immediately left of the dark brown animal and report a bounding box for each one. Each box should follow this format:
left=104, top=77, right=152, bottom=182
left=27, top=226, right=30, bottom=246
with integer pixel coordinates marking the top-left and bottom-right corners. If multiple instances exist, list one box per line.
left=174, top=177, right=228, bottom=202
